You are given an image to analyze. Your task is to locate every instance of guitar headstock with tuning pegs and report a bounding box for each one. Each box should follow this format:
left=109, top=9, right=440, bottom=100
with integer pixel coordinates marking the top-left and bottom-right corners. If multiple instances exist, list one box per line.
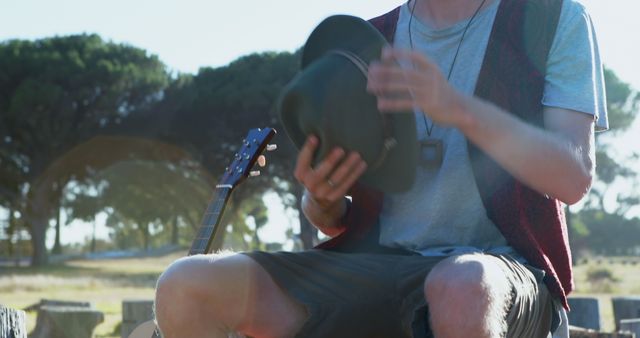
left=216, top=128, right=276, bottom=189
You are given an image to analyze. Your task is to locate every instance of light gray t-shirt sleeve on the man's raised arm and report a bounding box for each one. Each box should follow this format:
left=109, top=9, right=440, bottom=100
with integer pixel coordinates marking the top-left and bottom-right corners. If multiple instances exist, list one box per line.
left=542, top=0, right=609, bottom=131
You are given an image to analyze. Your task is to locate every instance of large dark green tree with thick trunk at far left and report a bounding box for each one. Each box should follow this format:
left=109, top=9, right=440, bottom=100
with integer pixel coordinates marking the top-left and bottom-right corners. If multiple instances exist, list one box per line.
left=0, top=35, right=168, bottom=265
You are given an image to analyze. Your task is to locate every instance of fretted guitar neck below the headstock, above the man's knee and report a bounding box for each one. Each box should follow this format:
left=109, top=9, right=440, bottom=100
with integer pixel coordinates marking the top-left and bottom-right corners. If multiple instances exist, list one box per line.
left=189, top=185, right=233, bottom=256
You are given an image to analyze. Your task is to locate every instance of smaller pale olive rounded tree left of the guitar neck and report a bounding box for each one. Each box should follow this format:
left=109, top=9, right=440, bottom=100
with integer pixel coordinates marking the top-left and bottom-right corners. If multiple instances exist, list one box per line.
left=100, top=160, right=212, bottom=250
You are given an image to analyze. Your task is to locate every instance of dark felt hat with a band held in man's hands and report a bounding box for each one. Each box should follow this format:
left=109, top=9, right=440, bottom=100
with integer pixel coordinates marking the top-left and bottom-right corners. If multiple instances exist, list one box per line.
left=278, top=15, right=418, bottom=192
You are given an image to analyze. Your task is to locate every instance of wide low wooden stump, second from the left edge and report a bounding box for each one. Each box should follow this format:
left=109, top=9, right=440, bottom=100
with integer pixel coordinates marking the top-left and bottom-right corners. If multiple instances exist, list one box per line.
left=29, top=306, right=104, bottom=338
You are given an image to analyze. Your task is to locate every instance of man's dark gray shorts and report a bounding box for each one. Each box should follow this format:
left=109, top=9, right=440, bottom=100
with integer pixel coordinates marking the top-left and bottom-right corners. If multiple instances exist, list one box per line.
left=245, top=250, right=554, bottom=338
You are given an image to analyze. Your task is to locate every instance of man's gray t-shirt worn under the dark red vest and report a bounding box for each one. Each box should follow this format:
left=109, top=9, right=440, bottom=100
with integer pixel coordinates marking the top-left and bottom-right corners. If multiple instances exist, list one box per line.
left=380, top=0, right=608, bottom=255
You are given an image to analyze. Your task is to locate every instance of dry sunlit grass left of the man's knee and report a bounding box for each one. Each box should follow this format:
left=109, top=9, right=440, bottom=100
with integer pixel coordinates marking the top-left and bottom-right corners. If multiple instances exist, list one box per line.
left=0, top=252, right=185, bottom=338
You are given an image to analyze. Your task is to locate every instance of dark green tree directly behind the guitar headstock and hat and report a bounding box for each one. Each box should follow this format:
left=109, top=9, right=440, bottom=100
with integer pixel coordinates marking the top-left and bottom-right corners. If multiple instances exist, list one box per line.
left=149, top=53, right=315, bottom=248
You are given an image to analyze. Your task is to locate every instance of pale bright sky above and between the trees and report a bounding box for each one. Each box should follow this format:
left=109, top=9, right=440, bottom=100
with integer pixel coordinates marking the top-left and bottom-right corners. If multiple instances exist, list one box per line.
left=0, top=0, right=640, bottom=248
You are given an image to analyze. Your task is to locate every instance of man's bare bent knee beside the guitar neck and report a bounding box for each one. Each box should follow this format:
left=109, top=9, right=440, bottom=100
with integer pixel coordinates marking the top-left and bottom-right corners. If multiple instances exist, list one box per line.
left=156, top=254, right=307, bottom=338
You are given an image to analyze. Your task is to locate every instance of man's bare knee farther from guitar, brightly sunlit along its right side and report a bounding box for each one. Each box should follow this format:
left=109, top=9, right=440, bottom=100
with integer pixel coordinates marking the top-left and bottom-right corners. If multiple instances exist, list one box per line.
left=425, top=255, right=511, bottom=338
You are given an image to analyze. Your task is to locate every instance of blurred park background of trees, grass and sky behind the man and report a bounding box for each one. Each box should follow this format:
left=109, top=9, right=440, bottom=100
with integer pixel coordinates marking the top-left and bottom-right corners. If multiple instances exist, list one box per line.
left=0, top=0, right=640, bottom=337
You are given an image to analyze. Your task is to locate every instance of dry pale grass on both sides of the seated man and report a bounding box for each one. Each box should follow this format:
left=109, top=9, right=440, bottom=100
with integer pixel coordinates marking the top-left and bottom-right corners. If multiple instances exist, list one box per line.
left=0, top=251, right=640, bottom=338
